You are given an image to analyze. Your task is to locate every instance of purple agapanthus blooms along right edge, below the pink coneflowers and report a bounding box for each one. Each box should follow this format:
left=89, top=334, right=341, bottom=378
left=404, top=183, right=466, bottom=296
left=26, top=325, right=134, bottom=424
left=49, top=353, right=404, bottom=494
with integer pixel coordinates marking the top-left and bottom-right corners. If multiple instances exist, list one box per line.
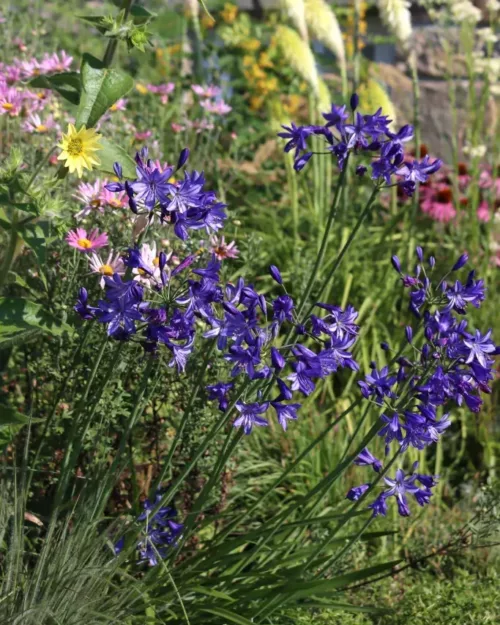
left=347, top=247, right=500, bottom=516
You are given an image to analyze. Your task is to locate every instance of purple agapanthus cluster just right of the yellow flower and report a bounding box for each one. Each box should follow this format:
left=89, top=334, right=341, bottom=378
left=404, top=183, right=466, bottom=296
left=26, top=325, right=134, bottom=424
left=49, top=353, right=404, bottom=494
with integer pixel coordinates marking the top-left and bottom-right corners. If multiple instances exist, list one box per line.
left=105, top=148, right=226, bottom=241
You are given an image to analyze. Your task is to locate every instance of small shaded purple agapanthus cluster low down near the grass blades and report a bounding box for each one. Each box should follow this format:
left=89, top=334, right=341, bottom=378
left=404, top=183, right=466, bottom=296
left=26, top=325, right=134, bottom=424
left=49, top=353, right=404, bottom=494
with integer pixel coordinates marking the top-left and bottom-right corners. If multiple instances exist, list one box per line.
left=115, top=493, right=184, bottom=566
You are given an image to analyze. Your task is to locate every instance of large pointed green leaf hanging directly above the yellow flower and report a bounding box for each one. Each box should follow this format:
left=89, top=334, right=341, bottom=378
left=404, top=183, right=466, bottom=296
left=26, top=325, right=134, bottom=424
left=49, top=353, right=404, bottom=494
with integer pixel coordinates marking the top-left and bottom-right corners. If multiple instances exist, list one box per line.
left=76, top=54, right=134, bottom=129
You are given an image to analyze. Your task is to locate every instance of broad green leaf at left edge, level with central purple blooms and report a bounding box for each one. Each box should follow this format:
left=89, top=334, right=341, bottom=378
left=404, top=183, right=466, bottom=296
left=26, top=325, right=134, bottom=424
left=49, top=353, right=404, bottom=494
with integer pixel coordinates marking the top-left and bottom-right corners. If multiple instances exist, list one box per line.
left=0, top=297, right=73, bottom=341
